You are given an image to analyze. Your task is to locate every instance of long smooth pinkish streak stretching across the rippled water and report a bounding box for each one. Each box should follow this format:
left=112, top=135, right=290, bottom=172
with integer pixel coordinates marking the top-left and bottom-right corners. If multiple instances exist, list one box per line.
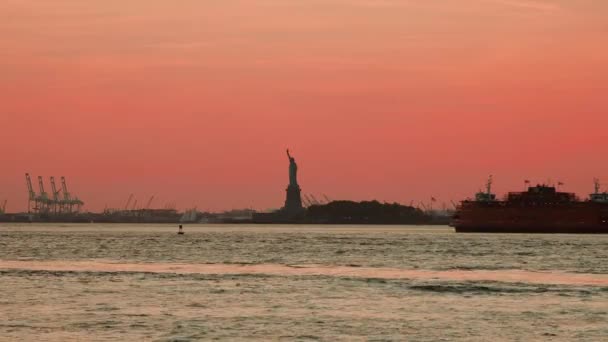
left=0, top=260, right=608, bottom=287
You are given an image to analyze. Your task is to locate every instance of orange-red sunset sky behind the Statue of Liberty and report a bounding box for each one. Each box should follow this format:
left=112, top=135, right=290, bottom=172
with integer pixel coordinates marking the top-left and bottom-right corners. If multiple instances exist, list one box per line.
left=0, top=0, right=608, bottom=211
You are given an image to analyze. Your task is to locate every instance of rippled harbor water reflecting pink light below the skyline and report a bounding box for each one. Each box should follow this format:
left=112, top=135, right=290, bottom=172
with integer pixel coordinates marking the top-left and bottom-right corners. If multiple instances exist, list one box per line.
left=0, top=224, right=608, bottom=341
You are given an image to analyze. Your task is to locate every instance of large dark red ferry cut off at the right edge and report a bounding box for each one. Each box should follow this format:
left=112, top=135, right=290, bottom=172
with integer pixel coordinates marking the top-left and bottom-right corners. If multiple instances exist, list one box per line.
left=450, top=177, right=608, bottom=234
